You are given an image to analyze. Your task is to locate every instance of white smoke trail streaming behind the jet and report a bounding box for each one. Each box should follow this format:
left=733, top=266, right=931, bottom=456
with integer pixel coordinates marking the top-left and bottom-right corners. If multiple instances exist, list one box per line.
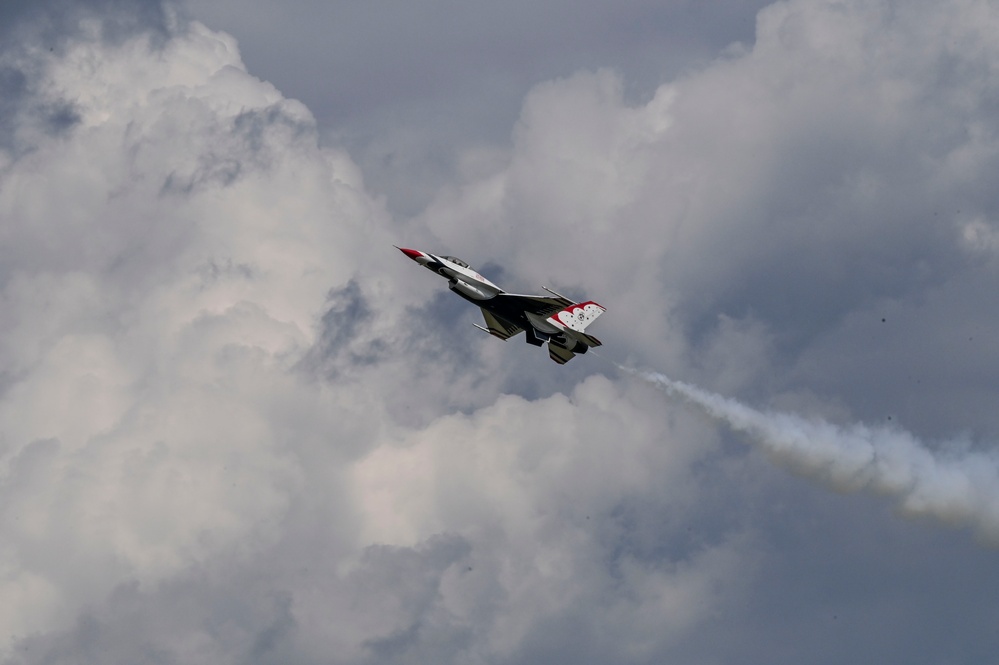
left=618, top=365, right=999, bottom=546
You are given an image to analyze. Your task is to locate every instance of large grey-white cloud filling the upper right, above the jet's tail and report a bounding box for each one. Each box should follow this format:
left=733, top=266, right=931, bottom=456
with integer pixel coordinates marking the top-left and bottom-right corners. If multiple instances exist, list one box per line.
left=423, top=2, right=996, bottom=400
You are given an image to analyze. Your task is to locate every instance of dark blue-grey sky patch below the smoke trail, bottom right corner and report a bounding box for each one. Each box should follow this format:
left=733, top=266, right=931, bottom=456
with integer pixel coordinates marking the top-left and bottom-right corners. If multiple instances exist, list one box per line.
left=677, top=466, right=996, bottom=665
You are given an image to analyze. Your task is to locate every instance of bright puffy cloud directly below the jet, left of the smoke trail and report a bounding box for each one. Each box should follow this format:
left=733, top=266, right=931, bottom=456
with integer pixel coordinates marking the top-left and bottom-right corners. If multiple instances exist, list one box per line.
left=353, top=377, right=749, bottom=662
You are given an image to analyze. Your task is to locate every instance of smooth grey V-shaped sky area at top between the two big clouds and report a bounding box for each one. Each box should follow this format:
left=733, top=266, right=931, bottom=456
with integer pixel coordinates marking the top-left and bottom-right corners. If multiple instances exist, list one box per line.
left=184, top=0, right=767, bottom=215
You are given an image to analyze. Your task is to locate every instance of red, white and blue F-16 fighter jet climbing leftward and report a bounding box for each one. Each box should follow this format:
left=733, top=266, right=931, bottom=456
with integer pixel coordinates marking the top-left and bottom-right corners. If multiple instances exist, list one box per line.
left=397, top=247, right=606, bottom=365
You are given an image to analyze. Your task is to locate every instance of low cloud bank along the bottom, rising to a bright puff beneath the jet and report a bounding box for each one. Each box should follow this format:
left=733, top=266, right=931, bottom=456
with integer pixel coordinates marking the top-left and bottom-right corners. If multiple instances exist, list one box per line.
left=3, top=378, right=755, bottom=663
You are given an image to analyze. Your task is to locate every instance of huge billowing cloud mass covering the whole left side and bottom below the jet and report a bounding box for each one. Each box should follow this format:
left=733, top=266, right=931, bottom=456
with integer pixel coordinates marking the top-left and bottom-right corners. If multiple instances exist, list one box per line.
left=0, top=2, right=750, bottom=662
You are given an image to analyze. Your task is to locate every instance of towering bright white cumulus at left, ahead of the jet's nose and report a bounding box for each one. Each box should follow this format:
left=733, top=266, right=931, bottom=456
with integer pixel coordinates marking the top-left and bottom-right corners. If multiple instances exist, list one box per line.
left=0, top=5, right=394, bottom=637
